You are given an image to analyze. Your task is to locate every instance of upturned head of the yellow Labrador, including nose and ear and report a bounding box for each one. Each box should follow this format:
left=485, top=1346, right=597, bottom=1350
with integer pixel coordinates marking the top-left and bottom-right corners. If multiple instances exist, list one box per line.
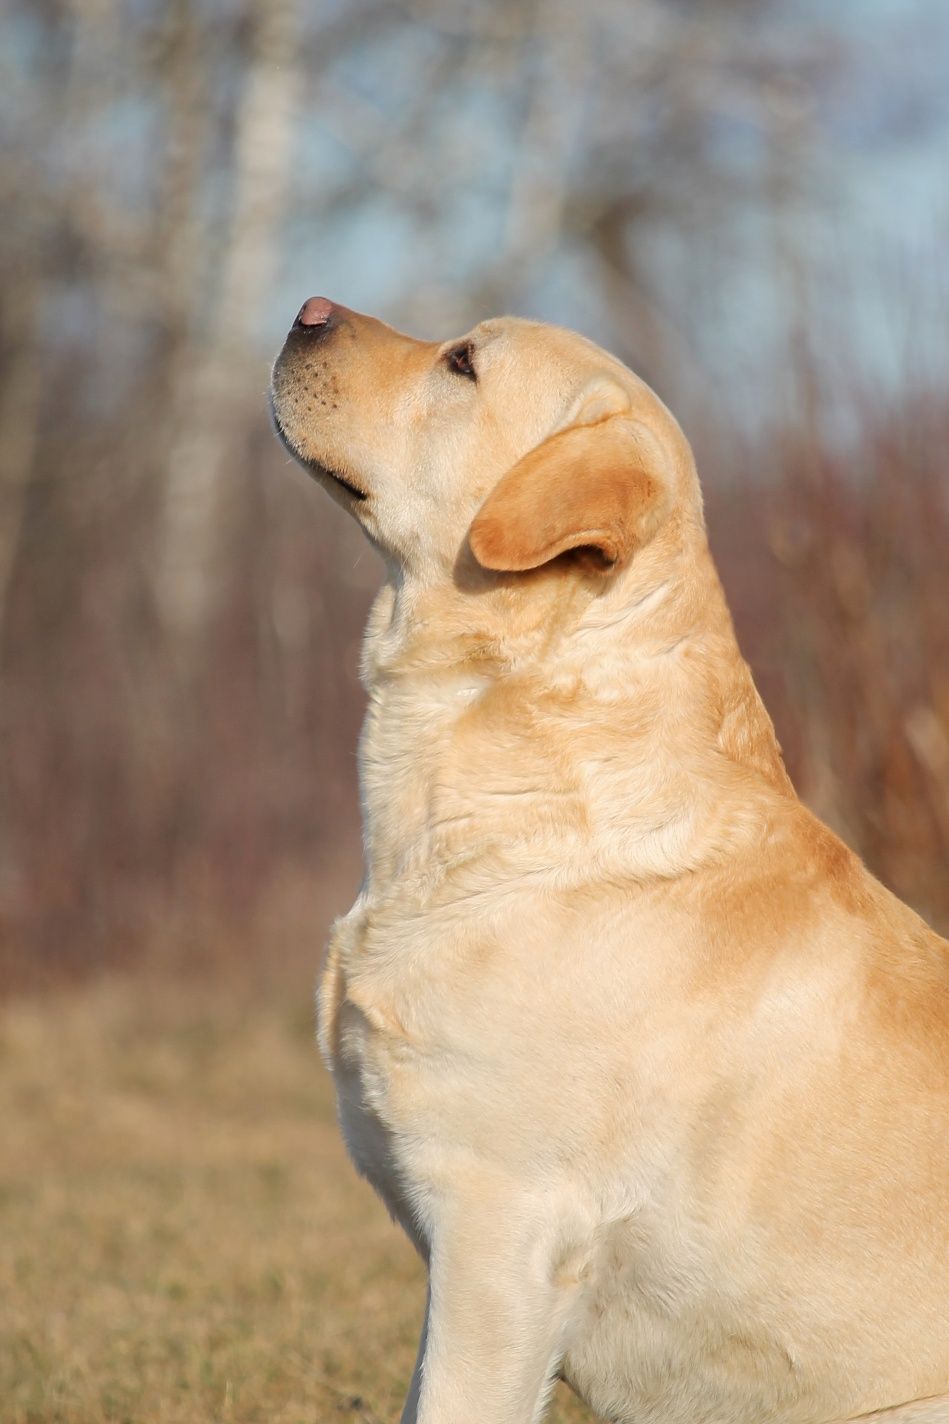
left=272, top=298, right=701, bottom=581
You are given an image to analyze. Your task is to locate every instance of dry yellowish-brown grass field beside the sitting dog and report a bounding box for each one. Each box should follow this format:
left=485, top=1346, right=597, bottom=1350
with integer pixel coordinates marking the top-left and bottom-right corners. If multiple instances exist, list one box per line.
left=0, top=977, right=588, bottom=1424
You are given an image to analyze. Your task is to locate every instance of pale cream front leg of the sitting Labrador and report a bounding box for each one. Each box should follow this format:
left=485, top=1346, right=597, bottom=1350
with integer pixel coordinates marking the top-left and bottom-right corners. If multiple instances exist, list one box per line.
left=402, top=1190, right=577, bottom=1424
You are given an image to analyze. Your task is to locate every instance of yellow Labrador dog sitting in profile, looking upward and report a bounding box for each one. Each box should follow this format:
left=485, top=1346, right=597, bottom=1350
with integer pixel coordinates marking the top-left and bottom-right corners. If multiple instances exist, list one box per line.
left=272, top=298, right=949, bottom=1424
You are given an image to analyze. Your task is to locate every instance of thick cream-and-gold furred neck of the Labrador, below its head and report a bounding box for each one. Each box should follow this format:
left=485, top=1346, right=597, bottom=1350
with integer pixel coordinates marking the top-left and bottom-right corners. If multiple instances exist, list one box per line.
left=350, top=528, right=792, bottom=896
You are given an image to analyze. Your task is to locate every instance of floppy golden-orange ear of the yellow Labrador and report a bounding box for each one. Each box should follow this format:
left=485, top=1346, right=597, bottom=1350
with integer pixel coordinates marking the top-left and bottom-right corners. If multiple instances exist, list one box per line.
left=469, top=397, right=670, bottom=572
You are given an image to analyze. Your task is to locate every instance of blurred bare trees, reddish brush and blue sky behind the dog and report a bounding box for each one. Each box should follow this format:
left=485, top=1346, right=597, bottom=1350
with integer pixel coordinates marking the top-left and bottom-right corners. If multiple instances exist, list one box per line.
left=0, top=0, right=949, bottom=987
